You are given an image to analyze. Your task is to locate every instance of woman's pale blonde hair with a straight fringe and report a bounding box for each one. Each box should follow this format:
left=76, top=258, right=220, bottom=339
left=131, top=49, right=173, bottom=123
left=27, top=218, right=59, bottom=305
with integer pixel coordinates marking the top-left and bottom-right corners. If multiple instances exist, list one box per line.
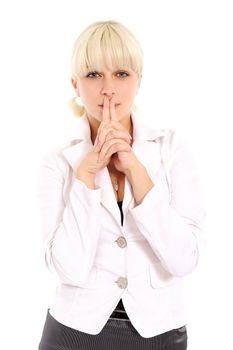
left=70, top=21, right=143, bottom=116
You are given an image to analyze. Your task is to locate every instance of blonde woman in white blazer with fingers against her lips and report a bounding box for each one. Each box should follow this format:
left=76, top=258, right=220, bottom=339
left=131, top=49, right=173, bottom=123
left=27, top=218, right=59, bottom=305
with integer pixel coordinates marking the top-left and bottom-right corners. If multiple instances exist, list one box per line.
left=39, top=21, right=204, bottom=350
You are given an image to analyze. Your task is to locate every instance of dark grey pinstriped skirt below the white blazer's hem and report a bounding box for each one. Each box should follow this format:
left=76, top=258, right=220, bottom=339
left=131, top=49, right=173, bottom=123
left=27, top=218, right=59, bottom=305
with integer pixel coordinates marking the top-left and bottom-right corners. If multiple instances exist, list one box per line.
left=39, top=309, right=187, bottom=350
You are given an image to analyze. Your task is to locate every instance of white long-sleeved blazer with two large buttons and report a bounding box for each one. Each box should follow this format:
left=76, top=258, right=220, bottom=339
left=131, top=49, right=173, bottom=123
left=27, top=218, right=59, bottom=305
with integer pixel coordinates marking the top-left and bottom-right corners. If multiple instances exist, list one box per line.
left=38, top=115, right=205, bottom=338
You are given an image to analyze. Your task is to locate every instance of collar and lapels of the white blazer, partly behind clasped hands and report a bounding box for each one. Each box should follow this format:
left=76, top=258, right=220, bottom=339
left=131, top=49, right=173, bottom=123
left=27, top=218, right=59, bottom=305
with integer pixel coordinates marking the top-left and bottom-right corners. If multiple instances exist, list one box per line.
left=62, top=114, right=166, bottom=222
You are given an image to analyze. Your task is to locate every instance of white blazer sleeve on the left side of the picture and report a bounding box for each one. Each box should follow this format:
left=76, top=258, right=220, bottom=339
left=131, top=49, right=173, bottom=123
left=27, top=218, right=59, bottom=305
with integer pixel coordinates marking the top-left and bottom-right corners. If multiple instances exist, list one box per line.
left=38, top=152, right=100, bottom=285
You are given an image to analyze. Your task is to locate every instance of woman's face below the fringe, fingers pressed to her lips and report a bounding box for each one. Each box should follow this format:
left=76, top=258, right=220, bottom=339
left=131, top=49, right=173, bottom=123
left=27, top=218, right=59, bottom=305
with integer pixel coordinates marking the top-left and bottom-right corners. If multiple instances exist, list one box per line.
left=72, top=68, right=139, bottom=121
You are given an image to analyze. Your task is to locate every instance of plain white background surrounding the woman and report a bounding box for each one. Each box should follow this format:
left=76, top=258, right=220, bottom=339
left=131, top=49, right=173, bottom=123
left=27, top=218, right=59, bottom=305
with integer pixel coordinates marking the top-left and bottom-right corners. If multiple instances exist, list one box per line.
left=0, top=0, right=233, bottom=350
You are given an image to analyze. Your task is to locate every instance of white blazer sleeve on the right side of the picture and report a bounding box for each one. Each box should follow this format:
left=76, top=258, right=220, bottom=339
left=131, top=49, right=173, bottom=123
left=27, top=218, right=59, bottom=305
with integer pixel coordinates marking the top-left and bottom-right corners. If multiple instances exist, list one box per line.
left=131, top=132, right=205, bottom=277
